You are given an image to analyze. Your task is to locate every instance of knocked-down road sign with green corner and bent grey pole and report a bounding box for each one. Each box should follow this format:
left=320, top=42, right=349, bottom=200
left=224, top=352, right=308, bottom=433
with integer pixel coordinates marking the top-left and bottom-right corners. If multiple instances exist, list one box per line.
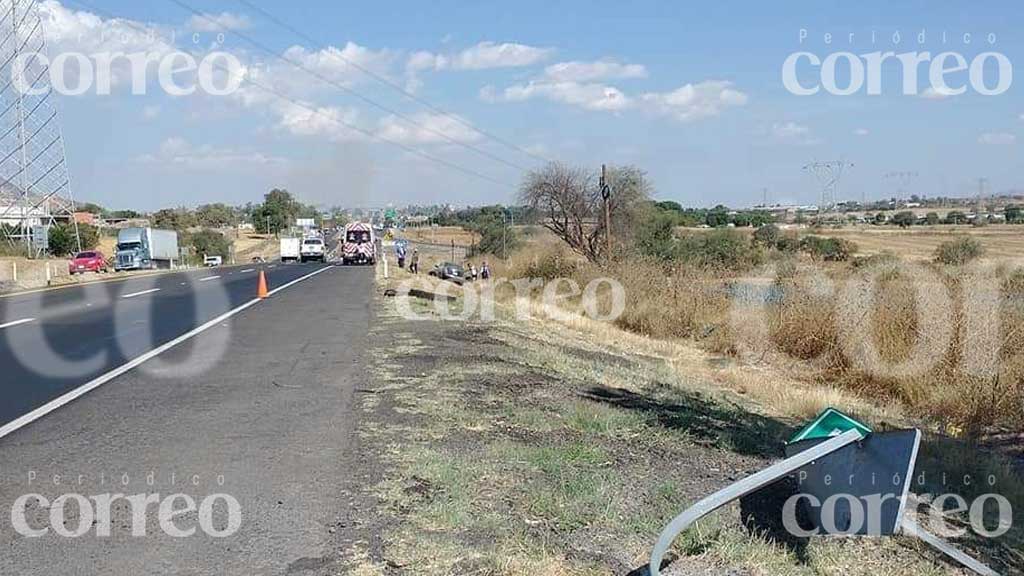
left=648, top=408, right=998, bottom=576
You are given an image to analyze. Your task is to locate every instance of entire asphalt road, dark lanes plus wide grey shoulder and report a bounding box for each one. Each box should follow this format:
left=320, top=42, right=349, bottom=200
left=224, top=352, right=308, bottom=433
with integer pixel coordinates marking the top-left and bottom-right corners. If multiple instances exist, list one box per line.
left=0, top=264, right=373, bottom=576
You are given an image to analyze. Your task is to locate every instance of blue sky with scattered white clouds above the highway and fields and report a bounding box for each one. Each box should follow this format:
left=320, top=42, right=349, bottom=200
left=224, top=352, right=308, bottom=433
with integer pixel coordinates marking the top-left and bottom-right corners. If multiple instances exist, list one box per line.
left=36, top=0, right=1024, bottom=209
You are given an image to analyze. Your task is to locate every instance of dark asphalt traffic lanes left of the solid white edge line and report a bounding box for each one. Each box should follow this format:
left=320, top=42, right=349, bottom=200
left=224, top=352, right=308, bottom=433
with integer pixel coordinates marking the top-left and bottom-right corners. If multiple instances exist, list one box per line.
left=0, top=264, right=329, bottom=426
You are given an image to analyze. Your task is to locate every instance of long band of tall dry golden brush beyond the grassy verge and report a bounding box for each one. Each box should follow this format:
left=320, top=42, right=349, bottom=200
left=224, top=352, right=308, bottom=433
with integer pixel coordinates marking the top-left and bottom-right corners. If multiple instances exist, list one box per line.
left=496, top=234, right=1024, bottom=436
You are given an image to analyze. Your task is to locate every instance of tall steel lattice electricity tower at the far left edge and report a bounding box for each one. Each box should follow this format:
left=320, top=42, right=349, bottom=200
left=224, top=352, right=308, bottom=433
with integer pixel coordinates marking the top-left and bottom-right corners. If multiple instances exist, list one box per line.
left=0, top=0, right=81, bottom=257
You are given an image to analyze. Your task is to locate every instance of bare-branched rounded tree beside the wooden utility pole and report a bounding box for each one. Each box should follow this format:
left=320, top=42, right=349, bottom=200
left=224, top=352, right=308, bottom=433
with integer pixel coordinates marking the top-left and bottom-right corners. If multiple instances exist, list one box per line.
left=519, top=162, right=650, bottom=262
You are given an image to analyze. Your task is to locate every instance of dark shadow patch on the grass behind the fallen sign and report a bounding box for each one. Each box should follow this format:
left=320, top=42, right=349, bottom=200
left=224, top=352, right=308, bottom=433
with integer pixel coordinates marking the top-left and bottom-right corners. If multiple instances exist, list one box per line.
left=583, top=386, right=795, bottom=457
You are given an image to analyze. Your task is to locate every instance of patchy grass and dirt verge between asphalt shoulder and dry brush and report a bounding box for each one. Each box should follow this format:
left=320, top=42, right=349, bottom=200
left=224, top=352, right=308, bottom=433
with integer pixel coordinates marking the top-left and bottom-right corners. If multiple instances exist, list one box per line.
left=340, top=282, right=958, bottom=575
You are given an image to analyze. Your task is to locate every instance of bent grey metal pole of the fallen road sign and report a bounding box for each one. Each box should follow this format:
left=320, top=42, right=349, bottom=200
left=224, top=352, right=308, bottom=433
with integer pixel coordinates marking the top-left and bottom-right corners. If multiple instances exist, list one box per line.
left=649, top=428, right=998, bottom=576
